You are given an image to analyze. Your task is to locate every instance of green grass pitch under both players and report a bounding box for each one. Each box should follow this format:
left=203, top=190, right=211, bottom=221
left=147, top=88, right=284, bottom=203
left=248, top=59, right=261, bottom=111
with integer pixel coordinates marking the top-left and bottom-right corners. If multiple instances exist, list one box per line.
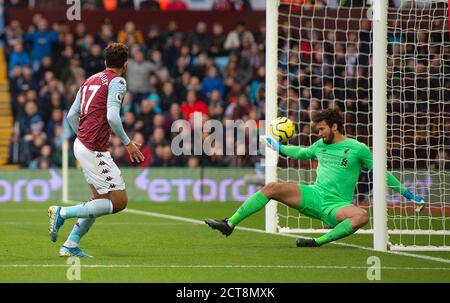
left=0, top=202, right=450, bottom=283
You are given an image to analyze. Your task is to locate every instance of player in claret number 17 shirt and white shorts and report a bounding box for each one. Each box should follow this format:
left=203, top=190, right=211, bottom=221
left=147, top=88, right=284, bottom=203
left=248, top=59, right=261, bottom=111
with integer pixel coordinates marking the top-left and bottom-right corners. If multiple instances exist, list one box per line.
left=48, top=43, right=144, bottom=257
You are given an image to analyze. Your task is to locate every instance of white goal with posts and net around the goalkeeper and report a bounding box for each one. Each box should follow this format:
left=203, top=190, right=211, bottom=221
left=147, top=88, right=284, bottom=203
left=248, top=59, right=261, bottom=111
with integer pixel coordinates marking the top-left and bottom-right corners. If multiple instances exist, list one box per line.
left=265, top=0, right=450, bottom=251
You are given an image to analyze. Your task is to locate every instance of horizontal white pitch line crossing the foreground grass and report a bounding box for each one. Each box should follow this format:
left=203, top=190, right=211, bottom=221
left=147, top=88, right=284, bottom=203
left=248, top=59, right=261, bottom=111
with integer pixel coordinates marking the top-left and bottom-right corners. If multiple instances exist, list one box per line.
left=0, top=264, right=450, bottom=271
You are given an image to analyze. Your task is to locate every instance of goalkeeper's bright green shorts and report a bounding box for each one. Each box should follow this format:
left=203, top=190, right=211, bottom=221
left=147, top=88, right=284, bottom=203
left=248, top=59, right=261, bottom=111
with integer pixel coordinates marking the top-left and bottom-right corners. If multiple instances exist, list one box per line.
left=298, top=184, right=352, bottom=227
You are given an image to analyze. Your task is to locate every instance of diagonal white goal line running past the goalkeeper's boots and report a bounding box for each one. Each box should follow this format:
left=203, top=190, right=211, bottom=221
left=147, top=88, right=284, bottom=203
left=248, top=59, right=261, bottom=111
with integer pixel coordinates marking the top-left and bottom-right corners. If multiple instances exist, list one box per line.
left=120, top=208, right=450, bottom=264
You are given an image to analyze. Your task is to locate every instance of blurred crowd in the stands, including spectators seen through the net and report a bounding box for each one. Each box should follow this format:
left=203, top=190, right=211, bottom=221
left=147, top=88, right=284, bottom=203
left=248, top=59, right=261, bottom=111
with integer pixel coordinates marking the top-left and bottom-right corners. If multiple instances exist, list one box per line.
left=5, top=0, right=450, bottom=173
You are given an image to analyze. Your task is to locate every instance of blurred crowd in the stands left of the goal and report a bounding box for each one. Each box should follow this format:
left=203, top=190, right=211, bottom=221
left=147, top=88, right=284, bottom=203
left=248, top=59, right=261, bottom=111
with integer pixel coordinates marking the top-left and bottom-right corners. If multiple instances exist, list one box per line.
left=5, top=14, right=265, bottom=168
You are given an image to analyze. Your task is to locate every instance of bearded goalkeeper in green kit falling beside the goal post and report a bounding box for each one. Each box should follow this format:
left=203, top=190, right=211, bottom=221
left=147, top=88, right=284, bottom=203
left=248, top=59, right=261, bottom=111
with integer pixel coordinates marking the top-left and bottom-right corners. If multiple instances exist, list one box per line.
left=205, top=109, right=425, bottom=247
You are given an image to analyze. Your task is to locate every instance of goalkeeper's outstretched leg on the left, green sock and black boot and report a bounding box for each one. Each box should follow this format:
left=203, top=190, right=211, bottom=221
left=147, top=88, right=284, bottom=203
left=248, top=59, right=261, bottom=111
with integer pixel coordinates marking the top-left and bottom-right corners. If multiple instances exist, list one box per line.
left=205, top=182, right=301, bottom=236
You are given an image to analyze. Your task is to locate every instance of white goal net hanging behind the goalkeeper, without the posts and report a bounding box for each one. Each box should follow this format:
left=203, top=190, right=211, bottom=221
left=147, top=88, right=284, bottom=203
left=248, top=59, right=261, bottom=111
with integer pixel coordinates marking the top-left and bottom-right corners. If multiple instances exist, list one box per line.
left=270, top=0, right=450, bottom=250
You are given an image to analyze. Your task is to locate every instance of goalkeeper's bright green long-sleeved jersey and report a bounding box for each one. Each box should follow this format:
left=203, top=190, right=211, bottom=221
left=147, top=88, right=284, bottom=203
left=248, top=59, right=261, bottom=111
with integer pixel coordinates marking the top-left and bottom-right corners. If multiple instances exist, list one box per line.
left=280, top=138, right=405, bottom=201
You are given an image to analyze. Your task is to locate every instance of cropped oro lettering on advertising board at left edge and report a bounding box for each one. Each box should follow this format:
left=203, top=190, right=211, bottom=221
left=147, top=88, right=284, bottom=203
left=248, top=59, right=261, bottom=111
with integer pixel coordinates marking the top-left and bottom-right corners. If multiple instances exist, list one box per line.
left=0, top=169, right=62, bottom=202
